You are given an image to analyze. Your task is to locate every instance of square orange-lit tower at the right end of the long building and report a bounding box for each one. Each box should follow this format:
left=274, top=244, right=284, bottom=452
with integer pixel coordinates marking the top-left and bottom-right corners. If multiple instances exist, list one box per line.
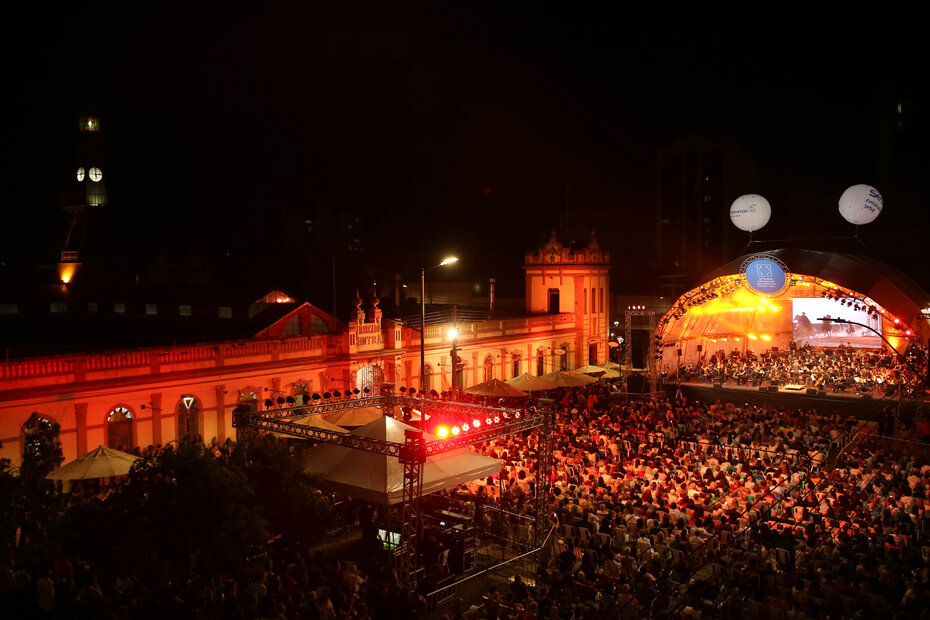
left=523, top=231, right=610, bottom=368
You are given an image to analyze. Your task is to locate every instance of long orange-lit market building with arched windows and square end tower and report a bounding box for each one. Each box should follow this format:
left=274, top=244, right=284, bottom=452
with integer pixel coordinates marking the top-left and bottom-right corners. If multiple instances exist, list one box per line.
left=0, top=235, right=610, bottom=463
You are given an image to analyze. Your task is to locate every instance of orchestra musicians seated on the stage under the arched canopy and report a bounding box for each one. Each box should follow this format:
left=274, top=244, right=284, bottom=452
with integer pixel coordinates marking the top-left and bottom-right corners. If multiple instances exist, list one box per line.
left=681, top=343, right=927, bottom=396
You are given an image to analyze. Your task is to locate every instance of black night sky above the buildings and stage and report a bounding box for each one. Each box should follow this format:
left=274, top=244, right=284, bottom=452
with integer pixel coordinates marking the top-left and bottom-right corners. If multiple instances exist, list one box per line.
left=0, top=2, right=930, bottom=306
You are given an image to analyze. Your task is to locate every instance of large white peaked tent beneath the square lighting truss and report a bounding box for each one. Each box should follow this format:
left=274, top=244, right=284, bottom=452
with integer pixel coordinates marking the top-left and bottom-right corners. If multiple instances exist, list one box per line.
left=306, top=417, right=501, bottom=506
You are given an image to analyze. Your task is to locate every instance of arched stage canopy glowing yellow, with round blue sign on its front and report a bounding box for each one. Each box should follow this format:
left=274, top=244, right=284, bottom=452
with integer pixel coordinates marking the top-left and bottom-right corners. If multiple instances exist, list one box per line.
left=654, top=248, right=930, bottom=368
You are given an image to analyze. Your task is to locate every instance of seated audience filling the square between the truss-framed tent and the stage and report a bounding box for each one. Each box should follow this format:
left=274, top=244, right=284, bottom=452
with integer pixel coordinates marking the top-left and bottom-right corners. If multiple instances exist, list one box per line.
left=454, top=388, right=930, bottom=618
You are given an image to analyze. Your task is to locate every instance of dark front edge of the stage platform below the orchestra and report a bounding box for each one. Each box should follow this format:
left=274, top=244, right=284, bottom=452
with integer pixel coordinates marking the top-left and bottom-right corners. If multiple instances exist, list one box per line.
left=663, top=383, right=915, bottom=420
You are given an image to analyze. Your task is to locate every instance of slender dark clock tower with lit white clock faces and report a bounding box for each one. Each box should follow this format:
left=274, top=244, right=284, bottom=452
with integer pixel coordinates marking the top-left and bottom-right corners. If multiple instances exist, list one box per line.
left=58, top=116, right=107, bottom=284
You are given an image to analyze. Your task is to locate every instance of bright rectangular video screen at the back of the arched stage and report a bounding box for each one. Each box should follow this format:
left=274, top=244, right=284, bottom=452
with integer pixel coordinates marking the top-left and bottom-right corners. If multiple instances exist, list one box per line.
left=791, top=297, right=882, bottom=349
